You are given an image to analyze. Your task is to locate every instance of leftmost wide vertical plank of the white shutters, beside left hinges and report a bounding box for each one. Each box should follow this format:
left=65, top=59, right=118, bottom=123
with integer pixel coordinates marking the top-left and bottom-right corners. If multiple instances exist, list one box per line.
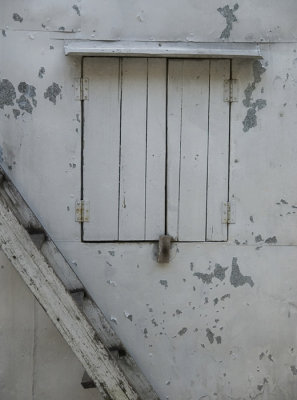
left=83, top=58, right=121, bottom=241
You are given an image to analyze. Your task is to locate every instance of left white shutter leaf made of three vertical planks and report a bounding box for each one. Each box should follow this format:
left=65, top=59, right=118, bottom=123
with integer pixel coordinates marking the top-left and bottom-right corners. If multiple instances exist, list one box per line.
left=83, top=58, right=166, bottom=241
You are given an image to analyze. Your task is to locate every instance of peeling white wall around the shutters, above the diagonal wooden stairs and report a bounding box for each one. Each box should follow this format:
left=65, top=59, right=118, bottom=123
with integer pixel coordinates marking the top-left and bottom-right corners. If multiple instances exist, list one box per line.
left=0, top=0, right=297, bottom=400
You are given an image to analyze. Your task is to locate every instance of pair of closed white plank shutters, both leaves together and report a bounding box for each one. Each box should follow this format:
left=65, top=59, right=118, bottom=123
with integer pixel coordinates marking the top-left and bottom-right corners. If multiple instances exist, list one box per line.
left=83, top=57, right=230, bottom=241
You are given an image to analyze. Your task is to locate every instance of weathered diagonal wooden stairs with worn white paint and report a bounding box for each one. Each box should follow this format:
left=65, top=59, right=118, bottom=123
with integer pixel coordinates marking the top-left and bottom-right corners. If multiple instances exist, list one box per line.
left=0, top=169, right=159, bottom=400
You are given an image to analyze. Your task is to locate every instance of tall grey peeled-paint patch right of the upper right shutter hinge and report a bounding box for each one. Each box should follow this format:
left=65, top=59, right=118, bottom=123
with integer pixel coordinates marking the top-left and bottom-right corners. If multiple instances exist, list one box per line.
left=242, top=60, right=267, bottom=132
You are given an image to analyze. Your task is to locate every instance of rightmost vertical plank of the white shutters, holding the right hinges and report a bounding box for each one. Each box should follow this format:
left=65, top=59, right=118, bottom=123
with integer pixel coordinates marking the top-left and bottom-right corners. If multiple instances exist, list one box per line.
left=206, top=60, right=230, bottom=241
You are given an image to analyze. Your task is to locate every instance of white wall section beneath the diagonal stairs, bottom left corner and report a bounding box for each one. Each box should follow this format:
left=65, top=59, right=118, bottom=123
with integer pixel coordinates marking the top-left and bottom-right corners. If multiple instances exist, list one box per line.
left=0, top=251, right=98, bottom=400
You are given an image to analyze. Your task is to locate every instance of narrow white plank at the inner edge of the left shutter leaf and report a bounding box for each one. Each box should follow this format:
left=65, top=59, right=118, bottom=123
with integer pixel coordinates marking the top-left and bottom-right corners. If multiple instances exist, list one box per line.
left=145, top=58, right=167, bottom=240
